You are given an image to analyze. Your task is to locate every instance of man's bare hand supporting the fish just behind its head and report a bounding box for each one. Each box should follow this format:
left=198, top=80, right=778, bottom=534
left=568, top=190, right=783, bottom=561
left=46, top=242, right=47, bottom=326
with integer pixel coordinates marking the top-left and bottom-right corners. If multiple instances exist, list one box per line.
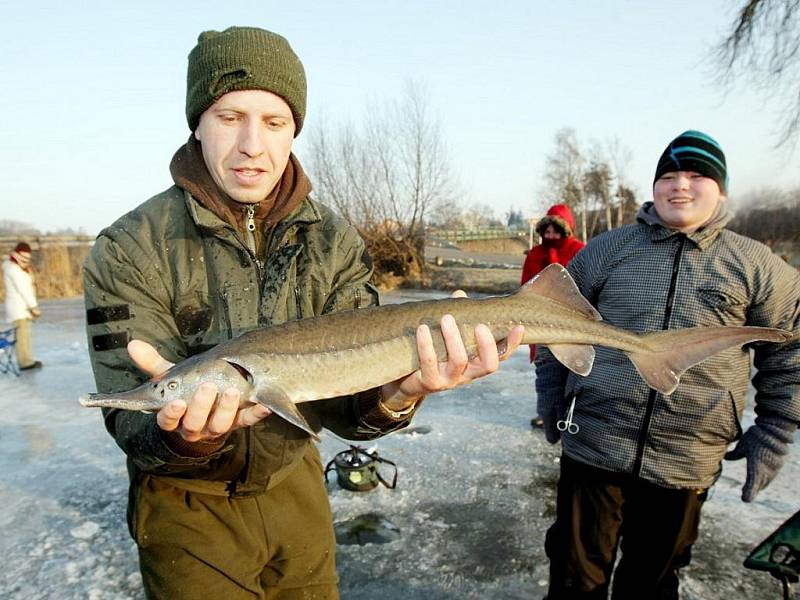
left=128, top=340, right=271, bottom=442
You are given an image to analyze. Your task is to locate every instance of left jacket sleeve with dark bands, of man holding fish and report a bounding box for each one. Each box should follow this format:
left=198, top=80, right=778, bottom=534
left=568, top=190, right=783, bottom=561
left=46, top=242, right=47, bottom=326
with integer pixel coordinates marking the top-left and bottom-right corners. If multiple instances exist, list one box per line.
left=84, top=234, right=244, bottom=480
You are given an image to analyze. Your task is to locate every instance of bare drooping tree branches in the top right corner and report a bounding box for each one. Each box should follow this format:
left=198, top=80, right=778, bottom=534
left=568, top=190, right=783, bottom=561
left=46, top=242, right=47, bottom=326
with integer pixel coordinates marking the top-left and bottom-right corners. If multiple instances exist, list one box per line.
left=716, top=0, right=800, bottom=146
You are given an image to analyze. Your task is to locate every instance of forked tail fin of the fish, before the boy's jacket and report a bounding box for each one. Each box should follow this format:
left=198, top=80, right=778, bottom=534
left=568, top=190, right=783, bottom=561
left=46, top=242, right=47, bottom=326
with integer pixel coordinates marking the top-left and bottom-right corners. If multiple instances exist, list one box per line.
left=625, top=327, right=792, bottom=394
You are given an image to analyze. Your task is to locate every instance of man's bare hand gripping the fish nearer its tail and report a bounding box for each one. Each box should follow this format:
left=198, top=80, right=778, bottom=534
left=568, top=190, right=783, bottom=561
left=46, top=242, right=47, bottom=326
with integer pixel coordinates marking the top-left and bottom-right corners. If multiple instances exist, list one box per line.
left=382, top=292, right=525, bottom=411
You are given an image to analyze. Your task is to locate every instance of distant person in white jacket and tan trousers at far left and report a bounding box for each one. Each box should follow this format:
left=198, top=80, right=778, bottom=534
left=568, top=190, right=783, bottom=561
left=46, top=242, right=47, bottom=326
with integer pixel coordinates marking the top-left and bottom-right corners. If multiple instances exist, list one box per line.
left=3, top=242, right=42, bottom=371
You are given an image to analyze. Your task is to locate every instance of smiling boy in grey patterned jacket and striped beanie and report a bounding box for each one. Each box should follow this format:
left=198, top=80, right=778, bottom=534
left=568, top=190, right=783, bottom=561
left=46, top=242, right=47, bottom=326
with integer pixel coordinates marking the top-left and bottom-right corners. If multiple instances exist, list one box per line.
left=536, top=131, right=800, bottom=600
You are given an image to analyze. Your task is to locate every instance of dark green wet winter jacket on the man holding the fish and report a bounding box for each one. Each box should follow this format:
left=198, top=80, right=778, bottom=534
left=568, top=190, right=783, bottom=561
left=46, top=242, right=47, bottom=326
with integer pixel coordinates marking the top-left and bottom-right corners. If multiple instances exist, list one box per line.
left=84, top=186, right=410, bottom=495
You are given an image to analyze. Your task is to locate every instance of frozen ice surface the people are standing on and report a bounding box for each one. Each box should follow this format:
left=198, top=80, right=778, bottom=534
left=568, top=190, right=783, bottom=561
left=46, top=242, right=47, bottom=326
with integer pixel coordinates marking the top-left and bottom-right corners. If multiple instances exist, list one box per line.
left=0, top=293, right=800, bottom=600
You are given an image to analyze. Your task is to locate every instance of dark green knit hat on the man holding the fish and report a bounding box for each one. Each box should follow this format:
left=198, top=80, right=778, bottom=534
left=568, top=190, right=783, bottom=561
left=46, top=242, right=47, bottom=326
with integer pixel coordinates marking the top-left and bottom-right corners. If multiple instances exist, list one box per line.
left=186, top=27, right=306, bottom=137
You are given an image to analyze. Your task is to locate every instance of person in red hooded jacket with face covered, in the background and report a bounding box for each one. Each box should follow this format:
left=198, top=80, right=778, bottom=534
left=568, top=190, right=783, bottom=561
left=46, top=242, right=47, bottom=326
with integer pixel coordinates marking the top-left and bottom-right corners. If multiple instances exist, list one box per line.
left=520, top=204, right=586, bottom=427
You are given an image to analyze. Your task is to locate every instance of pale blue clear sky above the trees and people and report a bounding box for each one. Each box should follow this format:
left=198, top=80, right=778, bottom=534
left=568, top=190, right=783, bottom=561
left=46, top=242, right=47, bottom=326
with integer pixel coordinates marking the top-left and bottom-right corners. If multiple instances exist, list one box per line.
left=0, top=0, right=800, bottom=233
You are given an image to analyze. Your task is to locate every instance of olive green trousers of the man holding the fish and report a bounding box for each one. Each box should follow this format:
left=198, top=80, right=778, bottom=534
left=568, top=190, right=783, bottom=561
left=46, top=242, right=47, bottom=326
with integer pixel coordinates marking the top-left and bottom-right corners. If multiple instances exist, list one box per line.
left=134, top=444, right=339, bottom=600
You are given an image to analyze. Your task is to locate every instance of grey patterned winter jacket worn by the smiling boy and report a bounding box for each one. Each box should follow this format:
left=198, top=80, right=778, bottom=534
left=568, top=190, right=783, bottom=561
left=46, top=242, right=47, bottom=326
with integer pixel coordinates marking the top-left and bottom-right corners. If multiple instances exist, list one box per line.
left=536, top=203, right=800, bottom=488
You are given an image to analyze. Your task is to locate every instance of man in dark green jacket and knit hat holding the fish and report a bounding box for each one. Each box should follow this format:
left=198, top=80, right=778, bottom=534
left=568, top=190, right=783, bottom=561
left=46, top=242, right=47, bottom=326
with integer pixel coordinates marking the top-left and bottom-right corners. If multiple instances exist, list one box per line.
left=85, top=27, right=522, bottom=599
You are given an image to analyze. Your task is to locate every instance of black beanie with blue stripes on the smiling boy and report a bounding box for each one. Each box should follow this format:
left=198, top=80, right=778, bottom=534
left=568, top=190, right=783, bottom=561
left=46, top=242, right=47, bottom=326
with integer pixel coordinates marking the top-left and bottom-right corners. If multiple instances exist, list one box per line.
left=653, top=130, right=728, bottom=194
